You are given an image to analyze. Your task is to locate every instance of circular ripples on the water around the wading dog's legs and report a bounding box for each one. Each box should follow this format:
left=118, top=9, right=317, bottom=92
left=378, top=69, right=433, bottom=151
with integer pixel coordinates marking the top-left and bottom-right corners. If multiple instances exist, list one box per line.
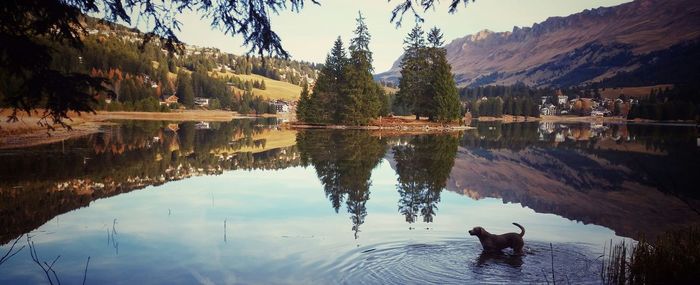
left=324, top=240, right=600, bottom=284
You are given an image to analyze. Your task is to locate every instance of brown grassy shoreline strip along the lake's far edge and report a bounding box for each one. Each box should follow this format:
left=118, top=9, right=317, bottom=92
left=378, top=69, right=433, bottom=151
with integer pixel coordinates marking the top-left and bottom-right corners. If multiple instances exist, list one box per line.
left=0, top=109, right=698, bottom=149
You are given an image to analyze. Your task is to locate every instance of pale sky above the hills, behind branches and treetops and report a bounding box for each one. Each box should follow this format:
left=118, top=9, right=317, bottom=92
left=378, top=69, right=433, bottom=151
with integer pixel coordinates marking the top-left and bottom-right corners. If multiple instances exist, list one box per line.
left=138, top=0, right=629, bottom=73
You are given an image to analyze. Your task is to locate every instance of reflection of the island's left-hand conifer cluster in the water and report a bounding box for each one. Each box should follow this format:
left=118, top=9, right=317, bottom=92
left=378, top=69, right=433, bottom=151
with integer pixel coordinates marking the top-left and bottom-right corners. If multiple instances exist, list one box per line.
left=297, top=130, right=386, bottom=238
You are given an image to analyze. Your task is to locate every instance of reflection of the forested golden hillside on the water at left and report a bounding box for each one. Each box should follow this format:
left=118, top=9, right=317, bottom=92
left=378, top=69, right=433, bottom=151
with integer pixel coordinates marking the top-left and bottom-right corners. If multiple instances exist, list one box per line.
left=0, top=120, right=299, bottom=244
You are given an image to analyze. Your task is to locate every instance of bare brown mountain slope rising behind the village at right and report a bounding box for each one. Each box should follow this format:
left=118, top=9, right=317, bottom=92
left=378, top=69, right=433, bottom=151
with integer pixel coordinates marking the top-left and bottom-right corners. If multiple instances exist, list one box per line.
left=375, top=0, right=700, bottom=87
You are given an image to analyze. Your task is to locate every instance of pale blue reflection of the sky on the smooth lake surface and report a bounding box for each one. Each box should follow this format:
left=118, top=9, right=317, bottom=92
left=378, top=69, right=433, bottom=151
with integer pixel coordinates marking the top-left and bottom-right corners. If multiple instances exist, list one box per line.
left=0, top=161, right=615, bottom=284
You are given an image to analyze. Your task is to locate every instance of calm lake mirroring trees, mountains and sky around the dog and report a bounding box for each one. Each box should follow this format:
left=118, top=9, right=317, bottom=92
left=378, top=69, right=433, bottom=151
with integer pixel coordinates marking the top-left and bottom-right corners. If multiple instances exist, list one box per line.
left=0, top=119, right=700, bottom=284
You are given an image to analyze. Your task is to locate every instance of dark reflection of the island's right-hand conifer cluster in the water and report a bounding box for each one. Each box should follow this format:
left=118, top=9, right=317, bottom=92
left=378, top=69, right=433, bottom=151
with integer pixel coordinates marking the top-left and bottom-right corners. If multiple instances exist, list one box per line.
left=392, top=135, right=459, bottom=223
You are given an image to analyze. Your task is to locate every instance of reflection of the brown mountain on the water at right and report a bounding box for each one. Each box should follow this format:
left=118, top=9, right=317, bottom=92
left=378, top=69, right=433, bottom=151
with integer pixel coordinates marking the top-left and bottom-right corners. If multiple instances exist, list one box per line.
left=447, top=121, right=700, bottom=237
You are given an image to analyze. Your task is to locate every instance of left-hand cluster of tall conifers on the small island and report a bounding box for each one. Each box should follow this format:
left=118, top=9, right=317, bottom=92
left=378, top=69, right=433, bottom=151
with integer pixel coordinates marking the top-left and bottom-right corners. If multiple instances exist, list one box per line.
left=297, top=13, right=389, bottom=125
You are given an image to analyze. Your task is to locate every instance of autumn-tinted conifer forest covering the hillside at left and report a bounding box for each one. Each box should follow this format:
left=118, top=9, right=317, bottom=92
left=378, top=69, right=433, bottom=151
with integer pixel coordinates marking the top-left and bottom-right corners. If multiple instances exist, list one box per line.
left=0, top=16, right=317, bottom=113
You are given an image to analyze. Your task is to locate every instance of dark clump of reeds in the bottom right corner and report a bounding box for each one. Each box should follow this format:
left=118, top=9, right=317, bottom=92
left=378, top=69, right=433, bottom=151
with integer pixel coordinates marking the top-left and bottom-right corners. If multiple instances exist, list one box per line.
left=601, top=226, right=700, bottom=284
